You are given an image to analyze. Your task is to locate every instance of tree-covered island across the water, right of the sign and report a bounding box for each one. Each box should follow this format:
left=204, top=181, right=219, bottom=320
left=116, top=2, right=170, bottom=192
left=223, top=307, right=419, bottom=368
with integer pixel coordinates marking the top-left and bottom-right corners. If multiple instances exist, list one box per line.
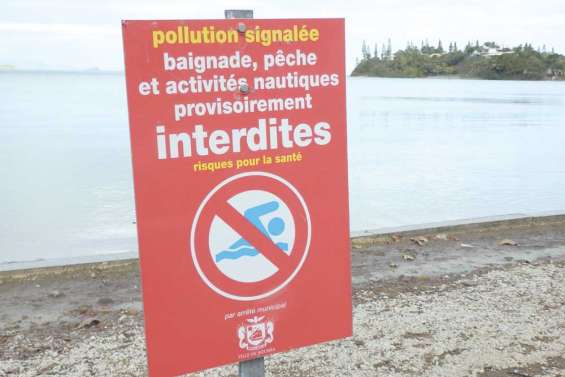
left=351, top=40, right=565, bottom=80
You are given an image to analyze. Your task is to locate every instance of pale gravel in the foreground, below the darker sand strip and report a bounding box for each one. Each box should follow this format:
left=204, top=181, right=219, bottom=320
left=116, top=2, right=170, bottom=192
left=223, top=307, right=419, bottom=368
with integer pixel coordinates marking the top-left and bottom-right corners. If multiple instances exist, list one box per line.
left=0, top=263, right=565, bottom=377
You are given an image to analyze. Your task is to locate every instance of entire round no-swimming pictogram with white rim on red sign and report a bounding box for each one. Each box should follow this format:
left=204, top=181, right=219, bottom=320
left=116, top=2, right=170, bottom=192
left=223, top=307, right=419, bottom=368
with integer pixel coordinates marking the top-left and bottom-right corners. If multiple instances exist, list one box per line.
left=190, top=172, right=311, bottom=301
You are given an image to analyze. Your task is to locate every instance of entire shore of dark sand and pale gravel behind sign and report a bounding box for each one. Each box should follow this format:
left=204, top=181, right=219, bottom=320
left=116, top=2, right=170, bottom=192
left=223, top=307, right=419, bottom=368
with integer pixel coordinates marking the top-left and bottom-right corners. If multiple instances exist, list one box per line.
left=0, top=216, right=565, bottom=377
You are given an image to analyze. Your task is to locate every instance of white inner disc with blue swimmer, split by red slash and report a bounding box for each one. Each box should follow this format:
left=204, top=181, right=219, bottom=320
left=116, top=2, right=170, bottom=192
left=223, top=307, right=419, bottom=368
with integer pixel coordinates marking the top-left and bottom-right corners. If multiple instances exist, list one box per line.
left=208, top=190, right=295, bottom=282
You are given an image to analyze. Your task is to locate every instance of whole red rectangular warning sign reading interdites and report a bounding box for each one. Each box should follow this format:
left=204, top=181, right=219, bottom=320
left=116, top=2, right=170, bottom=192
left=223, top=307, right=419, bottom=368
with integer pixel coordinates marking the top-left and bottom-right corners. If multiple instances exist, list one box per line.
left=123, top=19, right=352, bottom=376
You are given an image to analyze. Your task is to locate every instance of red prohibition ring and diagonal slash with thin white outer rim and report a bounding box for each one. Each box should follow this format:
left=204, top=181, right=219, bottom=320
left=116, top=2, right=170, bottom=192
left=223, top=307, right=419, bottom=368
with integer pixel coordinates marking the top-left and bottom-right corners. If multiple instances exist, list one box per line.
left=190, top=172, right=311, bottom=301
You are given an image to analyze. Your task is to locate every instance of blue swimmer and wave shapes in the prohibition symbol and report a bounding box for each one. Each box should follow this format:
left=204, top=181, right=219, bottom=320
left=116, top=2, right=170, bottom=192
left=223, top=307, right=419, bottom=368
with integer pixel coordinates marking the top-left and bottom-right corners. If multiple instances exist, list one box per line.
left=216, top=201, right=288, bottom=262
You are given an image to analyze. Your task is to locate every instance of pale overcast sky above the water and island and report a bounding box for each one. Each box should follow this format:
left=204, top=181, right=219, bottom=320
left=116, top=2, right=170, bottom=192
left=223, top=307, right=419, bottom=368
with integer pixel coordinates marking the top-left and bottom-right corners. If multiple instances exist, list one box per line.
left=0, top=0, right=565, bottom=71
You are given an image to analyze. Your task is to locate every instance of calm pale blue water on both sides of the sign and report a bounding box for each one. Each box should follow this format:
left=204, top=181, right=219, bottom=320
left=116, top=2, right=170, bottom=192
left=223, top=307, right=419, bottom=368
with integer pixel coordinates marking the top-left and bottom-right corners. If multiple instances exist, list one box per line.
left=0, top=73, right=565, bottom=263
